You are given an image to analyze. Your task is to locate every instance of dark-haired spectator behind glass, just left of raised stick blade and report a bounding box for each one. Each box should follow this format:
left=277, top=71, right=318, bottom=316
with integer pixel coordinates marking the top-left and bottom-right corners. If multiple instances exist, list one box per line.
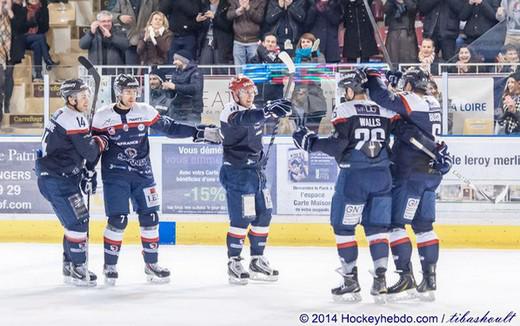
left=251, top=33, right=283, bottom=111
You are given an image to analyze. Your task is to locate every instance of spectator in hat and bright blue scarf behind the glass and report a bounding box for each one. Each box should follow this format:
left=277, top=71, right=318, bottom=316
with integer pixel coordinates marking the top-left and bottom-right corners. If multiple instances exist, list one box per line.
left=292, top=33, right=327, bottom=133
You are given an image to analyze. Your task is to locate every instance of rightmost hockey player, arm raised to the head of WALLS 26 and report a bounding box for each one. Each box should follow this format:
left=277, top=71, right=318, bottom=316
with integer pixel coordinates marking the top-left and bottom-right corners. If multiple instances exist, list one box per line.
left=367, top=68, right=451, bottom=300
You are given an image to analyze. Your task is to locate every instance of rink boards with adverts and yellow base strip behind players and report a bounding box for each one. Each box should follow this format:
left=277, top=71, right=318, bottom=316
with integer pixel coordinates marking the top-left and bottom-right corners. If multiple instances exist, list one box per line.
left=0, top=137, right=520, bottom=248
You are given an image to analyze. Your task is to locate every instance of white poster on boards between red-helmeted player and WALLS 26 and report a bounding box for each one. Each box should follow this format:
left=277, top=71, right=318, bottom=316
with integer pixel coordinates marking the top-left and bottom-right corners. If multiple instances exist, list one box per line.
left=276, top=145, right=338, bottom=216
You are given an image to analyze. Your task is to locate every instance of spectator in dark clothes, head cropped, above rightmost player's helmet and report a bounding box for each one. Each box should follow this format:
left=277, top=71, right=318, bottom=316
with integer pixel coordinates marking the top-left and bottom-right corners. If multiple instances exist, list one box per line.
left=417, top=0, right=463, bottom=61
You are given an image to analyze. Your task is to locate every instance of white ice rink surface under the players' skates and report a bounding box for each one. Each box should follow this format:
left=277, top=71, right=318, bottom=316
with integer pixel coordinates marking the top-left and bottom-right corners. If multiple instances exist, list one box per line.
left=0, top=243, right=520, bottom=326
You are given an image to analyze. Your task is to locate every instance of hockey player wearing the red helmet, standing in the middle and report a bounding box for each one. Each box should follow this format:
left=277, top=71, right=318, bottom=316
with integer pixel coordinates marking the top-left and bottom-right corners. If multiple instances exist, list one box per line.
left=220, top=75, right=292, bottom=285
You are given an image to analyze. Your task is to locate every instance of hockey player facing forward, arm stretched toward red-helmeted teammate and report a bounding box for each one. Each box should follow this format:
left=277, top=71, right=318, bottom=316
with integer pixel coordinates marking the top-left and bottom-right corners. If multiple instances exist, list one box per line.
left=92, top=74, right=219, bottom=285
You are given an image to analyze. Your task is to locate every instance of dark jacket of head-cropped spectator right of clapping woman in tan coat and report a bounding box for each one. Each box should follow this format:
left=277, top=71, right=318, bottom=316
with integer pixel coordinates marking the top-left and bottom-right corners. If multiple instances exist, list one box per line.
left=159, top=0, right=205, bottom=36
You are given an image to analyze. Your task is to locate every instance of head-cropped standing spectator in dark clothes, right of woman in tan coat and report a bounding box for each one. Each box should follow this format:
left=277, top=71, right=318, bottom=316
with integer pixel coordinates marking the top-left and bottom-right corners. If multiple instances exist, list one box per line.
left=161, top=0, right=207, bottom=62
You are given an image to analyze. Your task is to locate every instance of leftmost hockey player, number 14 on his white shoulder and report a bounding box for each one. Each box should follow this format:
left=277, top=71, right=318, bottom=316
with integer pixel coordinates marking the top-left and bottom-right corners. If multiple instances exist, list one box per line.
left=35, top=79, right=107, bottom=286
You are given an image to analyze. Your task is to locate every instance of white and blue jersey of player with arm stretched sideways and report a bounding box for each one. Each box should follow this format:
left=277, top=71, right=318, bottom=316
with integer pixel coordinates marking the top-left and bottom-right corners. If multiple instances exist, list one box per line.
left=92, top=103, right=197, bottom=179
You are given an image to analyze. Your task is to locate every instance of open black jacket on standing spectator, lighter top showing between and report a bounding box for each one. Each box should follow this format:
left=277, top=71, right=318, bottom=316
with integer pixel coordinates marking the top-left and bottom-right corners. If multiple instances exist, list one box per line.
left=197, top=0, right=233, bottom=64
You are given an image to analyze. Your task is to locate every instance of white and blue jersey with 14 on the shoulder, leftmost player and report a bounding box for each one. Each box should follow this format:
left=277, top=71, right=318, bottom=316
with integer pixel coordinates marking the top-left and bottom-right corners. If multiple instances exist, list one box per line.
left=35, top=106, right=99, bottom=177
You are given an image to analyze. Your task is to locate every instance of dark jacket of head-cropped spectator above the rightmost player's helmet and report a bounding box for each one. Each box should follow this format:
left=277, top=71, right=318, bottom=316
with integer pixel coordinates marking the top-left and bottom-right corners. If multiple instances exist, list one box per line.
left=417, top=0, right=465, bottom=38
